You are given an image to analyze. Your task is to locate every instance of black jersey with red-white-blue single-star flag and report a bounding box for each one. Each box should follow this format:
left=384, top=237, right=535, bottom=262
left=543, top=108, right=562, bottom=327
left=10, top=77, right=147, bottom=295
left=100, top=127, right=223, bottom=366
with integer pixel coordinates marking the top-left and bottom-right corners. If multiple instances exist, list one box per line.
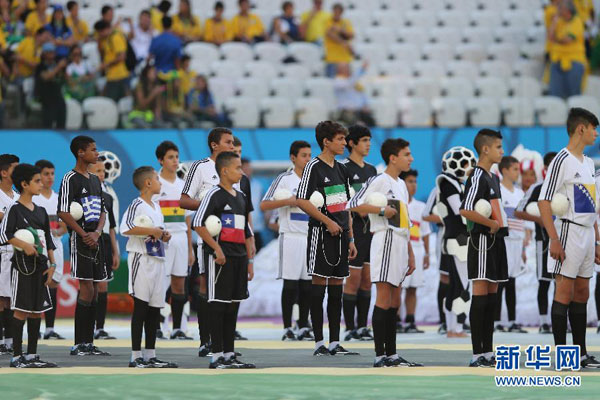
left=192, top=185, right=252, bottom=257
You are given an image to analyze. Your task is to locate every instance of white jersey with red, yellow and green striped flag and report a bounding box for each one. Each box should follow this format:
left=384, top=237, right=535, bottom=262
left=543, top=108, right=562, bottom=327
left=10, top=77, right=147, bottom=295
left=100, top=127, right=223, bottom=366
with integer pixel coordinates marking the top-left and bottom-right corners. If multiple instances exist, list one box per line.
left=152, top=175, right=187, bottom=232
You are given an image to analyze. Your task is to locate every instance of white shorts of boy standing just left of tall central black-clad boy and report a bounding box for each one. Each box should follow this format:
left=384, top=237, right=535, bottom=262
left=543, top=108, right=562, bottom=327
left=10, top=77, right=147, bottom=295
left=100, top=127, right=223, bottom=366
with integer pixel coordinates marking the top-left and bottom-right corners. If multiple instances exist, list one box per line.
left=277, top=233, right=311, bottom=281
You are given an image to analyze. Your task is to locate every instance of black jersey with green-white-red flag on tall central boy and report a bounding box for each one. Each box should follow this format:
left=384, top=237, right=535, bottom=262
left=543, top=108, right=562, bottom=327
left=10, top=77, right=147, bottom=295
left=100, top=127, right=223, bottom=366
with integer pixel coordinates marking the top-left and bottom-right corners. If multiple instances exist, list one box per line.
left=296, top=157, right=350, bottom=231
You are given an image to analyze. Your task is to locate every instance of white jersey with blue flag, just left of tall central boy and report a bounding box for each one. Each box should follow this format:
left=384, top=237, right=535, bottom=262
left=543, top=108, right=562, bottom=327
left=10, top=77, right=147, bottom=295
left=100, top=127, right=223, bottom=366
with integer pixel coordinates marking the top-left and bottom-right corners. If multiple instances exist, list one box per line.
left=263, top=171, right=308, bottom=235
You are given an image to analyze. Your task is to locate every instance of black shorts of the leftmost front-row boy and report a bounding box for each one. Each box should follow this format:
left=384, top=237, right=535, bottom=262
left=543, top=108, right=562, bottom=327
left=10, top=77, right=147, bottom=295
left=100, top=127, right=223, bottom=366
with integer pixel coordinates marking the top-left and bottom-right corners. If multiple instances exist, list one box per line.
left=10, top=262, right=52, bottom=313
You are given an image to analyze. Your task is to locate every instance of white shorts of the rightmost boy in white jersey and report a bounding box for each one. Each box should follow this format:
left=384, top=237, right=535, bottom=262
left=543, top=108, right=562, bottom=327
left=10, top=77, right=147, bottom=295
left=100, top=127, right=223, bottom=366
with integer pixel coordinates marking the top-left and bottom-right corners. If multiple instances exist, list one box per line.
left=548, top=220, right=596, bottom=279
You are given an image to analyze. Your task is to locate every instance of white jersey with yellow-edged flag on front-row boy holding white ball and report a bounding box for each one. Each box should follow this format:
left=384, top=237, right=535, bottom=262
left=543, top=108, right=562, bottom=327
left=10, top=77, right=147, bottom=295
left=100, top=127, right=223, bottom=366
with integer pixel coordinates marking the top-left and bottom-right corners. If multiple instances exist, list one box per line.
left=346, top=172, right=410, bottom=237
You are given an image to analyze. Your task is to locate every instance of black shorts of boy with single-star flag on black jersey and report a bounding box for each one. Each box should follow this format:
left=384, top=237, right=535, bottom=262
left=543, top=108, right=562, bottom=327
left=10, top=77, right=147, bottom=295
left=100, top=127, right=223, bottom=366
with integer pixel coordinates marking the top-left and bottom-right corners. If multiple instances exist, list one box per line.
left=204, top=252, right=248, bottom=303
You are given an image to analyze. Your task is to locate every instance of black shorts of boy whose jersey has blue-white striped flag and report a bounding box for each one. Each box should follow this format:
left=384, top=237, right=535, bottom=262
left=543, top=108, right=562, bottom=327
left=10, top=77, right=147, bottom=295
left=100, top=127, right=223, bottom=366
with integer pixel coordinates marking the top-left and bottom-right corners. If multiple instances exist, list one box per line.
left=69, top=232, right=108, bottom=282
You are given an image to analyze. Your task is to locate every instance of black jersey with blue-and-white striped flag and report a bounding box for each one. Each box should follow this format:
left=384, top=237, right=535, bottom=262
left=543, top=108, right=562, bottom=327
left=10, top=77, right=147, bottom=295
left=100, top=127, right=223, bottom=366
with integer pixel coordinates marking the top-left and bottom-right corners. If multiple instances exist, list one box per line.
left=57, top=170, right=105, bottom=232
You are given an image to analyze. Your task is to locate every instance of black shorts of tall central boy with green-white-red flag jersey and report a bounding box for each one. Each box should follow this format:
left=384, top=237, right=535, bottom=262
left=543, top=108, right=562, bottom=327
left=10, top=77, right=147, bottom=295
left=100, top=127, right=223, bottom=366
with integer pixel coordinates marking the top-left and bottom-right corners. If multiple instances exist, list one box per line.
left=306, top=226, right=350, bottom=279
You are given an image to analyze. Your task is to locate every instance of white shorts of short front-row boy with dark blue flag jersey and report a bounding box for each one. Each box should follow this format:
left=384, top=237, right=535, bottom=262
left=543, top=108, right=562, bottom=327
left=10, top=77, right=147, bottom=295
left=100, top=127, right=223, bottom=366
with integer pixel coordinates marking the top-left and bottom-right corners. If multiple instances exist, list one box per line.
left=127, top=253, right=165, bottom=308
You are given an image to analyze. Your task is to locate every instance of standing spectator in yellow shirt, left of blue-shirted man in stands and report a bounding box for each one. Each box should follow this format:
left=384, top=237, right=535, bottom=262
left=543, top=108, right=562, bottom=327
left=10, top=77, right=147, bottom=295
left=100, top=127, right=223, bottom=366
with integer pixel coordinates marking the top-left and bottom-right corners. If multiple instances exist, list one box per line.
left=94, top=20, right=129, bottom=101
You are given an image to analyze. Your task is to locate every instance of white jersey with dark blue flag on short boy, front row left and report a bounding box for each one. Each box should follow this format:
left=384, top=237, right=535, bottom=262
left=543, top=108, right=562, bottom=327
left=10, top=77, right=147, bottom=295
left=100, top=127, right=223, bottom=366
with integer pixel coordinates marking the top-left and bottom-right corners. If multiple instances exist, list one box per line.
left=120, top=197, right=165, bottom=257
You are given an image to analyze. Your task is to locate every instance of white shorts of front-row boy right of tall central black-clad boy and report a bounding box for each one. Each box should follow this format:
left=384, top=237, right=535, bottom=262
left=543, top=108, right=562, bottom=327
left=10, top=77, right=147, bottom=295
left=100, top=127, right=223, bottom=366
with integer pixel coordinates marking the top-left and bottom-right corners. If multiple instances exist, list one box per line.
left=371, top=229, right=408, bottom=287
